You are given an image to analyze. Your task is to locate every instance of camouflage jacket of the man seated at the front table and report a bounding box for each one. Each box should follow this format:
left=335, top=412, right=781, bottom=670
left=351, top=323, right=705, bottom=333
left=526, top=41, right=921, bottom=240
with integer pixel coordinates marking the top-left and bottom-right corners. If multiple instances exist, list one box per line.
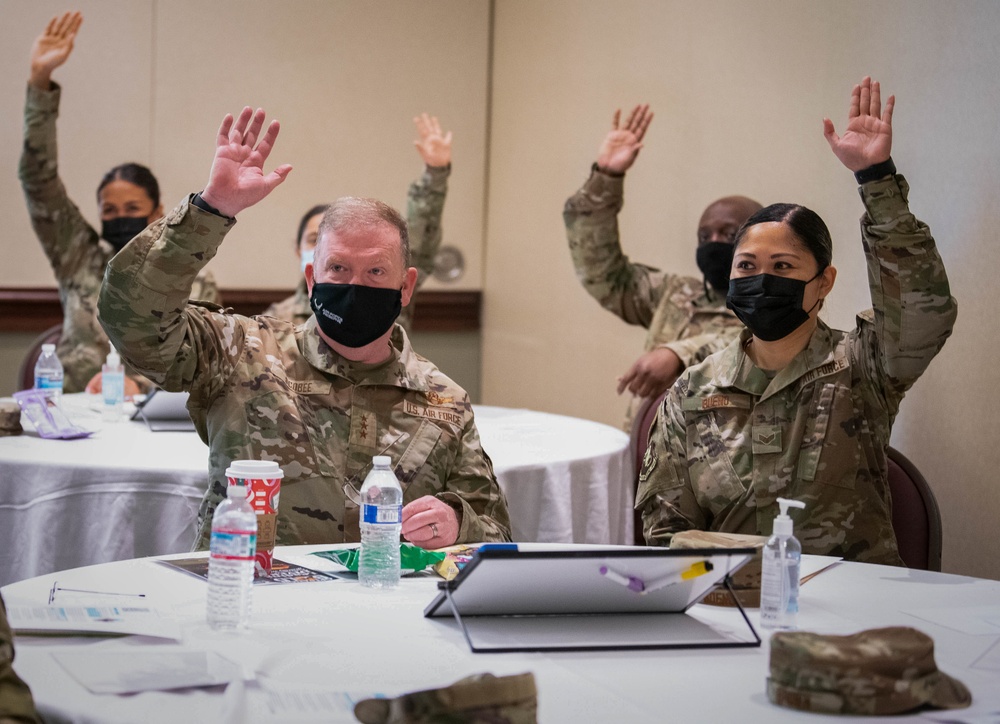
left=99, top=195, right=510, bottom=546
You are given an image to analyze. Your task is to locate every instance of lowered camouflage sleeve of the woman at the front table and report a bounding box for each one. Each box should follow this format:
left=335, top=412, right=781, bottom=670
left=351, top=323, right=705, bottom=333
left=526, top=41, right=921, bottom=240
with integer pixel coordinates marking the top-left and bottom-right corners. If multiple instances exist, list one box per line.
left=635, top=376, right=711, bottom=546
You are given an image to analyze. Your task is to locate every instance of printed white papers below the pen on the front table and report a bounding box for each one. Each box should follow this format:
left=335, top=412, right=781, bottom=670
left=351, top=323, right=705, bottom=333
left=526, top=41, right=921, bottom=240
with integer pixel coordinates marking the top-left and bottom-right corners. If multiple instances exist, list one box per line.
left=7, top=606, right=181, bottom=641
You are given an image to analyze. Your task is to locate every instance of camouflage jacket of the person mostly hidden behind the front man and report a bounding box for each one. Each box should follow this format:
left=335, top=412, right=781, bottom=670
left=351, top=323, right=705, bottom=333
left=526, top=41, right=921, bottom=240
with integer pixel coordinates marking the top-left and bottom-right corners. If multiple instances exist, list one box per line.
left=264, top=166, right=451, bottom=332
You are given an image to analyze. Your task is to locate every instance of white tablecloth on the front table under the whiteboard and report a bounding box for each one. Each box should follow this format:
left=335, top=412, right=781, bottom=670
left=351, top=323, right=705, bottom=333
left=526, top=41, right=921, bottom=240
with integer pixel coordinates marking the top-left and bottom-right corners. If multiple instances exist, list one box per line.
left=3, top=546, right=1000, bottom=724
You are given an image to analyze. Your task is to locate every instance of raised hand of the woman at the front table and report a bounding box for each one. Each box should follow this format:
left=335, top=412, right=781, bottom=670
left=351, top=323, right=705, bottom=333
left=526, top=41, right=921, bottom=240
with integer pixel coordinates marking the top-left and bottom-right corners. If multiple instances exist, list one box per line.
left=823, top=76, right=896, bottom=171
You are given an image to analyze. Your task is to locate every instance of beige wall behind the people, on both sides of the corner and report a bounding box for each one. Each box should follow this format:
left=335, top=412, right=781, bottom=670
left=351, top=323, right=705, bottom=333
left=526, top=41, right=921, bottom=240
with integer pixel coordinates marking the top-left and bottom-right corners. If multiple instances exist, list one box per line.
left=0, top=0, right=1000, bottom=578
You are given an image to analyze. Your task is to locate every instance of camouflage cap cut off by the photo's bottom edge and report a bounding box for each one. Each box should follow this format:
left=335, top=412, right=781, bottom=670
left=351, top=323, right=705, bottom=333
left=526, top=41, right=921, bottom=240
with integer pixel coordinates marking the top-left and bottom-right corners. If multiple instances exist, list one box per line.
left=354, top=672, right=538, bottom=724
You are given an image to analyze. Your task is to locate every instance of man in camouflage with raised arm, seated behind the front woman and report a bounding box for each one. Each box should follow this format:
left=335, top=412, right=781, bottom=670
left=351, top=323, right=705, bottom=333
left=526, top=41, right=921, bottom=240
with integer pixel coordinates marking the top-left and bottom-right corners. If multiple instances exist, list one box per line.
left=563, top=106, right=760, bottom=431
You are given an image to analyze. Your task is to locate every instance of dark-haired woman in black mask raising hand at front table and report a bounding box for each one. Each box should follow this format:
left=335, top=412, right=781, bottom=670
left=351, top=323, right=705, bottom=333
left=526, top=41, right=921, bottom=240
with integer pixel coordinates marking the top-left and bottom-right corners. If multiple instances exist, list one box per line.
left=636, top=78, right=957, bottom=565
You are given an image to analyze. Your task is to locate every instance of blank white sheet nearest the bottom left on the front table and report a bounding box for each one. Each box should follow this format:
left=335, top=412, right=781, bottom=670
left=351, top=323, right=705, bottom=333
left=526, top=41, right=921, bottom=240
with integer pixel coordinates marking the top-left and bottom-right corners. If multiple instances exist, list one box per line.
left=52, top=648, right=242, bottom=694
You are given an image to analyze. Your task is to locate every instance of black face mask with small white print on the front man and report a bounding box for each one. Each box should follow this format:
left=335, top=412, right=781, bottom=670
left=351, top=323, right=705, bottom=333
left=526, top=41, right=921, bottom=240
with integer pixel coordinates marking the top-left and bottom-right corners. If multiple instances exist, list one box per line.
left=309, top=282, right=403, bottom=347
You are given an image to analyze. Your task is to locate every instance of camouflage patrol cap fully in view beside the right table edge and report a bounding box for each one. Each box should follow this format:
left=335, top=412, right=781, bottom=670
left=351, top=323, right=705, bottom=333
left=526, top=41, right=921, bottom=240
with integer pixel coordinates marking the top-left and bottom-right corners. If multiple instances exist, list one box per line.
left=767, top=626, right=972, bottom=715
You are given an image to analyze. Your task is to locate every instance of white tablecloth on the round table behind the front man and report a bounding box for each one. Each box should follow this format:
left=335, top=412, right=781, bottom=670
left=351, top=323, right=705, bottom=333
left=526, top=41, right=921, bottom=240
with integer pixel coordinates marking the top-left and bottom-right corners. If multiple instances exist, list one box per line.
left=0, top=394, right=633, bottom=585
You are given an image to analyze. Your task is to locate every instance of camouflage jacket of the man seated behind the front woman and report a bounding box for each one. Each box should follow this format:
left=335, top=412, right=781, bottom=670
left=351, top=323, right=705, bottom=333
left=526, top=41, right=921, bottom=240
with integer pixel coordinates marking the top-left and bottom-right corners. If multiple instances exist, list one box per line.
left=563, top=168, right=743, bottom=429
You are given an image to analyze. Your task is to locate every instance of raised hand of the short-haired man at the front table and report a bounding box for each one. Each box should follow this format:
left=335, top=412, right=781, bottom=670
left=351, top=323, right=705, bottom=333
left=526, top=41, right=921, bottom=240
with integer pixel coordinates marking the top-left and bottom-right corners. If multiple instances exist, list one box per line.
left=201, top=106, right=292, bottom=216
